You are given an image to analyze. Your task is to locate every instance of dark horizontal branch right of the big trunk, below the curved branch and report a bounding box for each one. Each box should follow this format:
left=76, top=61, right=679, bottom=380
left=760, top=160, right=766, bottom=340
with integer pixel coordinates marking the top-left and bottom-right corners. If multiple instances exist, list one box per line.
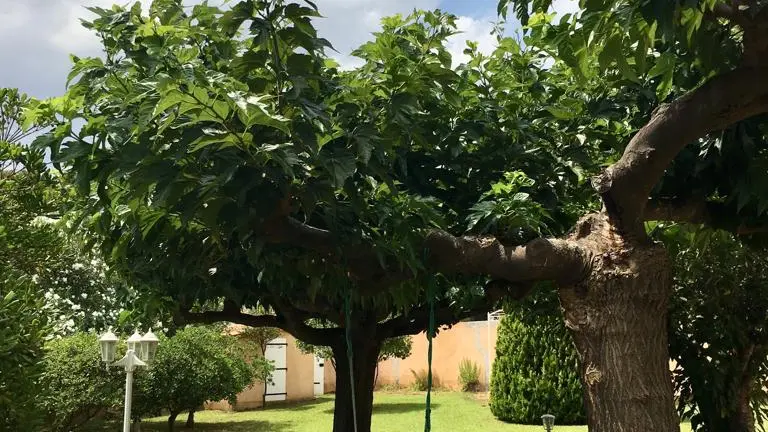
left=644, top=200, right=768, bottom=235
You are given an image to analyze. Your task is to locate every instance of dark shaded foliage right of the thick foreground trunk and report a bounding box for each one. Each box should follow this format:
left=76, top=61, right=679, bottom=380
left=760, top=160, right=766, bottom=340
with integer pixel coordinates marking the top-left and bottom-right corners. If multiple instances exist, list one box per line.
left=664, top=226, right=768, bottom=432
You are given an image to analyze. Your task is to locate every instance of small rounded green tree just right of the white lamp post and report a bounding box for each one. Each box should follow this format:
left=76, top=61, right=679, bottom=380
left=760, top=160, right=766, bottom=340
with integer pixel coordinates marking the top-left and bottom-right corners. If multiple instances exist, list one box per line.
left=136, top=327, right=272, bottom=430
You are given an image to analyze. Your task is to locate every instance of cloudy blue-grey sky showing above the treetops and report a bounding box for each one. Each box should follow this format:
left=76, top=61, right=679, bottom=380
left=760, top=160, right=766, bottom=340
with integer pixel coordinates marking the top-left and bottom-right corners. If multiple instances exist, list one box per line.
left=0, top=0, right=577, bottom=98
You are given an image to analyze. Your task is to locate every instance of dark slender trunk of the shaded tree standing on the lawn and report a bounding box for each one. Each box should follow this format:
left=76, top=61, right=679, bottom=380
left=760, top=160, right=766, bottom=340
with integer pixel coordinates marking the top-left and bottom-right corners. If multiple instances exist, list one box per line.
left=331, top=323, right=381, bottom=432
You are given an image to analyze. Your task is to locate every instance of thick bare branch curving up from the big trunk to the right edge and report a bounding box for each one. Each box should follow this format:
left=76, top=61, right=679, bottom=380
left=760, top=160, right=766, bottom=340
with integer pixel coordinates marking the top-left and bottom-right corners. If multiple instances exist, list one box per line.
left=594, top=67, right=768, bottom=235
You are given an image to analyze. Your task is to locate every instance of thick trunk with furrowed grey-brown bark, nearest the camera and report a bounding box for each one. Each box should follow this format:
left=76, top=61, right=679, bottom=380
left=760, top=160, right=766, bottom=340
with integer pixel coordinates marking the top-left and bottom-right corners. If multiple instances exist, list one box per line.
left=560, top=215, right=680, bottom=432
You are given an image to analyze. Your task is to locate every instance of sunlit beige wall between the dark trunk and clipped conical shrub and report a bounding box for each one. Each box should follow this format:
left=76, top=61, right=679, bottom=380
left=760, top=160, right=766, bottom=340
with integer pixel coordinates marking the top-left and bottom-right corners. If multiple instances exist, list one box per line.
left=376, top=321, right=499, bottom=389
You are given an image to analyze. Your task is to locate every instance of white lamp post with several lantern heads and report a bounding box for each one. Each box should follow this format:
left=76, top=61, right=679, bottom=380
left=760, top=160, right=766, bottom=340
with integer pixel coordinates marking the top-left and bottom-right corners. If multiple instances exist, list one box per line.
left=99, top=330, right=159, bottom=432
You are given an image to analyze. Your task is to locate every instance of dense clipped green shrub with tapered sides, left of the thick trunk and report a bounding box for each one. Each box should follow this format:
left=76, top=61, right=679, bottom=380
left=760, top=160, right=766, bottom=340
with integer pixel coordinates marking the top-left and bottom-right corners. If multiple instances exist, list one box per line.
left=490, top=311, right=586, bottom=424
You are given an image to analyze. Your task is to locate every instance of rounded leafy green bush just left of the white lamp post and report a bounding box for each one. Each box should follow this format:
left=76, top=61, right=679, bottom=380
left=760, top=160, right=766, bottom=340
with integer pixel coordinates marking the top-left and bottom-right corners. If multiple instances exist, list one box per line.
left=38, top=333, right=124, bottom=431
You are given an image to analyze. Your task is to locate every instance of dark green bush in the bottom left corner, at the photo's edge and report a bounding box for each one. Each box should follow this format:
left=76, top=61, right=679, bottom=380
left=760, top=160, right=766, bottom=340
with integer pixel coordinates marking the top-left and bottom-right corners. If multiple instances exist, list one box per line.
left=0, top=276, right=51, bottom=430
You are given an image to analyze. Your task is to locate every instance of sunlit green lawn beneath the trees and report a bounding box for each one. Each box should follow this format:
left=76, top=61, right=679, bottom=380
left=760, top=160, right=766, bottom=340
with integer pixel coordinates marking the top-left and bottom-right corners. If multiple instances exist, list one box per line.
left=136, top=392, right=689, bottom=432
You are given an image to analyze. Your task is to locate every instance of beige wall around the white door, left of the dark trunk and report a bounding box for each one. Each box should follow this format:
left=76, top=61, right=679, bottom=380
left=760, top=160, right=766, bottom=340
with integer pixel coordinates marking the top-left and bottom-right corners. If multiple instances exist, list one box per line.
left=205, top=326, right=318, bottom=411
